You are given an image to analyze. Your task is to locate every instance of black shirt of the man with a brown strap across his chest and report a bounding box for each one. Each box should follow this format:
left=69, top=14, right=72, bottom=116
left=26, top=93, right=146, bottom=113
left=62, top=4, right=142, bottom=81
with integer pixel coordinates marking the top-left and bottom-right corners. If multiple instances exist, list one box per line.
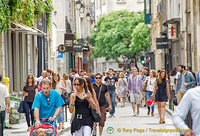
left=93, top=83, right=108, bottom=107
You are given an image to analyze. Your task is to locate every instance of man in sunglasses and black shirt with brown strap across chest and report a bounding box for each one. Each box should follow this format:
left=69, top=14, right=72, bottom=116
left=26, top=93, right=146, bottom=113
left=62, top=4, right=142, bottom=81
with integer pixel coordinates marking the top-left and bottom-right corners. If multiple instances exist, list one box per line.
left=93, top=73, right=112, bottom=136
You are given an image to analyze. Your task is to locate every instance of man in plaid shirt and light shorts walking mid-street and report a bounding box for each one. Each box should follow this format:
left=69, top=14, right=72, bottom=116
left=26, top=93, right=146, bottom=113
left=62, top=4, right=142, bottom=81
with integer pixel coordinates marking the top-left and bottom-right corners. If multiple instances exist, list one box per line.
left=127, top=68, right=143, bottom=116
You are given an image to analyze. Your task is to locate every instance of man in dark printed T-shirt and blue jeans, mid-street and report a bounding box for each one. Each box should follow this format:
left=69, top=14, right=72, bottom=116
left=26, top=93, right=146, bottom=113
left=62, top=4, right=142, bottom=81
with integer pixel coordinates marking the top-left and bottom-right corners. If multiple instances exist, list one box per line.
left=104, top=68, right=118, bottom=117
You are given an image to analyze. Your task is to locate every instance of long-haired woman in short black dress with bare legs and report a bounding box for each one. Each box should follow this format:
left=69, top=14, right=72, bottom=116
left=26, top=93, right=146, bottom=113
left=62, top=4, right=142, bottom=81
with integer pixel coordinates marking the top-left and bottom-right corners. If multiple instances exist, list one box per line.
left=152, top=70, right=170, bottom=124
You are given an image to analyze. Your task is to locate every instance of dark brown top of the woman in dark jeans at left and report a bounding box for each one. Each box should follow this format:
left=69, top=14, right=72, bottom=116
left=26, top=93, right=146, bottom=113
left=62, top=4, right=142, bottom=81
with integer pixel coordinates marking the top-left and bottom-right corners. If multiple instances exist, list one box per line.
left=23, top=85, right=38, bottom=102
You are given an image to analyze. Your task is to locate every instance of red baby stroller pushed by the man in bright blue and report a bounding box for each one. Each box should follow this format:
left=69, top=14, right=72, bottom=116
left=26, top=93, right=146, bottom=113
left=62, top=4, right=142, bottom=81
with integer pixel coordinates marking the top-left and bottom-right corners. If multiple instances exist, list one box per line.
left=29, top=119, right=57, bottom=136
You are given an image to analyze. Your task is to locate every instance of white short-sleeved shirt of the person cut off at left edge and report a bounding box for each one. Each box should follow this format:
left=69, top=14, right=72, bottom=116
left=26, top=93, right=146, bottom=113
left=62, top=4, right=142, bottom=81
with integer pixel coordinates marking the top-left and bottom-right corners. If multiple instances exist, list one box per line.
left=0, top=84, right=9, bottom=111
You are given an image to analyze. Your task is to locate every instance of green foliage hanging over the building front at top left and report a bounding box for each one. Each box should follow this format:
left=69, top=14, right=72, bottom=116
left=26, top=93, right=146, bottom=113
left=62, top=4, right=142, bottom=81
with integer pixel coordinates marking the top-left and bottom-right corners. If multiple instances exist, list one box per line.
left=0, top=0, right=54, bottom=32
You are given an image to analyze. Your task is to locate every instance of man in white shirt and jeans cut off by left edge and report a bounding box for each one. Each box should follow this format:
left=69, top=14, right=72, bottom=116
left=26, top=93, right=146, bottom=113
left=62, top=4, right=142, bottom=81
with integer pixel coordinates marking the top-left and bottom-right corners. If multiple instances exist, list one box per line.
left=0, top=75, right=10, bottom=136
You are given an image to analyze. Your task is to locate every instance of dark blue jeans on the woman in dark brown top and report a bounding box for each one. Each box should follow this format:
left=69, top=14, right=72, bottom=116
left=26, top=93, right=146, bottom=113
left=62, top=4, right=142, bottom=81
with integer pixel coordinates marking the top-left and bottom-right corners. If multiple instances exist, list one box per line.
left=24, top=102, right=34, bottom=127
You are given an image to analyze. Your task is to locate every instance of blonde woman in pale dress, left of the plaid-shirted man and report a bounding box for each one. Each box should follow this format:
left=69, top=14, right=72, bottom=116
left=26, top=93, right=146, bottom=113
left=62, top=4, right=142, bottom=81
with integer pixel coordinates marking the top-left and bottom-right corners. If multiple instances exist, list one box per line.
left=117, top=72, right=128, bottom=107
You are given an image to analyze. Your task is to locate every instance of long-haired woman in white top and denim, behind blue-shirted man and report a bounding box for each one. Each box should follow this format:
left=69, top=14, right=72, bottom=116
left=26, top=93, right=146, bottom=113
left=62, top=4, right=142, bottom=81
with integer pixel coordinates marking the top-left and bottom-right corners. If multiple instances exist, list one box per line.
left=52, top=74, right=66, bottom=130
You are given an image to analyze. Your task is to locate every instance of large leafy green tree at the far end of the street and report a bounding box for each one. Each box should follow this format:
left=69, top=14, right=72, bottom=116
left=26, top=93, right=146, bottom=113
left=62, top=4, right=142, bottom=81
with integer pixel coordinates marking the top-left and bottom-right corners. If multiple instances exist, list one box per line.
left=92, top=10, right=149, bottom=60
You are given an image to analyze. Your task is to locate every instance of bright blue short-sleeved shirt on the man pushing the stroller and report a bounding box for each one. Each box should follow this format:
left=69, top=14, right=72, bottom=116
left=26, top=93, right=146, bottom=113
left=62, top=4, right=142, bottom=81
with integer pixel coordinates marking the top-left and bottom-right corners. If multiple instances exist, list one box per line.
left=32, top=90, right=64, bottom=124
